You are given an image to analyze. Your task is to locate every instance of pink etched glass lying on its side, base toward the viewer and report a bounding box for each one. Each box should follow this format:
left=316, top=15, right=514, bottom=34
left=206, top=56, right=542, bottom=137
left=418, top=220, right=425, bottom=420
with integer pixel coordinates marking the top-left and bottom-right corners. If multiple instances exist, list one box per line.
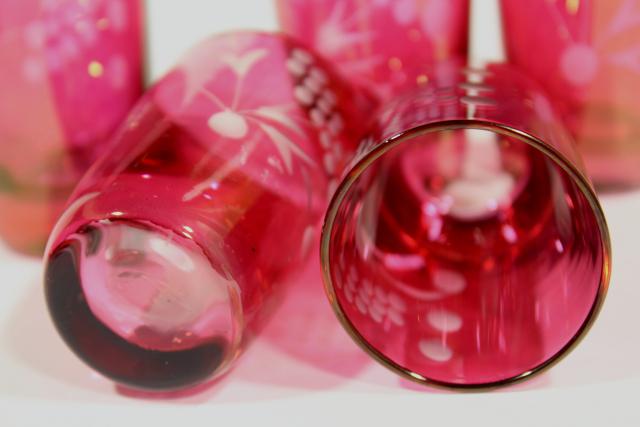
left=45, top=32, right=369, bottom=390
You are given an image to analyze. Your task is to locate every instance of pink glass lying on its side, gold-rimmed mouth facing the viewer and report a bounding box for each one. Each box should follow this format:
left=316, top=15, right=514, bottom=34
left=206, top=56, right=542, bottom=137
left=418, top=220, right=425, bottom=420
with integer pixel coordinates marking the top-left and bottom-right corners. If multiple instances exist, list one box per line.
left=321, top=65, right=610, bottom=387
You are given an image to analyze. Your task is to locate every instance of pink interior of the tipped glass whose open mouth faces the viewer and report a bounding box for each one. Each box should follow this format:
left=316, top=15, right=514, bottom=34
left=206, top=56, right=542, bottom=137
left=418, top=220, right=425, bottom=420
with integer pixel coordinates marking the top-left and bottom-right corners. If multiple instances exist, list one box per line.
left=328, top=129, right=605, bottom=385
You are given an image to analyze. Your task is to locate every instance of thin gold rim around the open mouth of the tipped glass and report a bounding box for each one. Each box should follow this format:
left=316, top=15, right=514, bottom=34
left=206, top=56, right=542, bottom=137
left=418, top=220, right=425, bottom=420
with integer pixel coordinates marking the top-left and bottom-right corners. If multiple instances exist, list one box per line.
left=320, top=119, right=611, bottom=390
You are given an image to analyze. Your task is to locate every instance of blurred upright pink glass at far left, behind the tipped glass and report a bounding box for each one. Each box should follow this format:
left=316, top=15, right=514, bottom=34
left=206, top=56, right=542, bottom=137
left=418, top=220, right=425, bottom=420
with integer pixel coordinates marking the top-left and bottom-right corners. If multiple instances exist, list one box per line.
left=0, top=0, right=142, bottom=254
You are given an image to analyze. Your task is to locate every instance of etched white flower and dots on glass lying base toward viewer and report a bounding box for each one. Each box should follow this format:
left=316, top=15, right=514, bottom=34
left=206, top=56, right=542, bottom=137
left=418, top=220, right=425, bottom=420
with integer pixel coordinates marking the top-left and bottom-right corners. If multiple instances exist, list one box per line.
left=157, top=33, right=370, bottom=207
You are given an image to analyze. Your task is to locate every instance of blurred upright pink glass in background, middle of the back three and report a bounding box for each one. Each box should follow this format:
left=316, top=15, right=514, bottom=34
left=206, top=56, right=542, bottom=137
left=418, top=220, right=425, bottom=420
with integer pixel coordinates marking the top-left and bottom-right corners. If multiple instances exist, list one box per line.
left=276, top=0, right=469, bottom=98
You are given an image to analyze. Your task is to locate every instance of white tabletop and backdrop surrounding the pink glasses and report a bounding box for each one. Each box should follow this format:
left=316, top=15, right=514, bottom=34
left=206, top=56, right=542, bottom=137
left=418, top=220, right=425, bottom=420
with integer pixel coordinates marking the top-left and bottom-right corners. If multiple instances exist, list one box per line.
left=0, top=0, right=640, bottom=427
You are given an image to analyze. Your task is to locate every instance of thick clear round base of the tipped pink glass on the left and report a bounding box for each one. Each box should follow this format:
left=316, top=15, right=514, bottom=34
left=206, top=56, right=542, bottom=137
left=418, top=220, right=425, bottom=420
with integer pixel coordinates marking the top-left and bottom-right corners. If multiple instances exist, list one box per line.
left=46, top=220, right=241, bottom=389
